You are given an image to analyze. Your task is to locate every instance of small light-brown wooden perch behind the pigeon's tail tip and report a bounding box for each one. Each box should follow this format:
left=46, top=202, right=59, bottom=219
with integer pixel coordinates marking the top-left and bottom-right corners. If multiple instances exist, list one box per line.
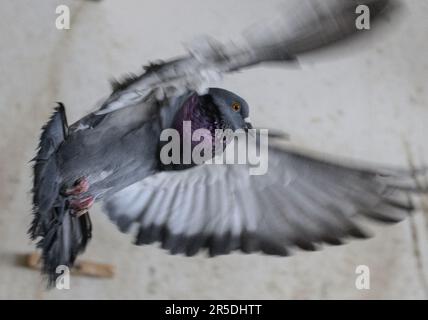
left=25, top=252, right=115, bottom=278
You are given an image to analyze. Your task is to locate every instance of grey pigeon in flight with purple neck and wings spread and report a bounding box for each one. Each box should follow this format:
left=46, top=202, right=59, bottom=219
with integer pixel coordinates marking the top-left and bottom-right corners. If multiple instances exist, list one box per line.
left=29, top=0, right=426, bottom=285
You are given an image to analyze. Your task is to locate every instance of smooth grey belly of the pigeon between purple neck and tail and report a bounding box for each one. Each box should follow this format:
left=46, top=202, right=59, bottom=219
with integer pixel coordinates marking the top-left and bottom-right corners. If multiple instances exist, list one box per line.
left=57, top=96, right=162, bottom=198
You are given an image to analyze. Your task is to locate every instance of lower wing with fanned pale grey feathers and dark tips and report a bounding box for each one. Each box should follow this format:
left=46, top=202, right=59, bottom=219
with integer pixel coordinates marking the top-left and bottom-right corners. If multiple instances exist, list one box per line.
left=105, top=141, right=424, bottom=255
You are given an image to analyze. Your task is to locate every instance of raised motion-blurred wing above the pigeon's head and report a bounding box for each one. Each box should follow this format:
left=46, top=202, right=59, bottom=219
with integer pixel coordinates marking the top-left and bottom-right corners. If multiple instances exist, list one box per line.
left=96, top=0, right=391, bottom=115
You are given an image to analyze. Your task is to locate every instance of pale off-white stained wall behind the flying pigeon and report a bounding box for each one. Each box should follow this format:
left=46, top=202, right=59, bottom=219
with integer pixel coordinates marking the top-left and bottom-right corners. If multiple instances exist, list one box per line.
left=0, top=0, right=428, bottom=299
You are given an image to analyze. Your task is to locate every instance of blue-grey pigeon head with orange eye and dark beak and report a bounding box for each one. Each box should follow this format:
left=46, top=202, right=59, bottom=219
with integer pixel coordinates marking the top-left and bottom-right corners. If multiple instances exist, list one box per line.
left=205, top=88, right=252, bottom=131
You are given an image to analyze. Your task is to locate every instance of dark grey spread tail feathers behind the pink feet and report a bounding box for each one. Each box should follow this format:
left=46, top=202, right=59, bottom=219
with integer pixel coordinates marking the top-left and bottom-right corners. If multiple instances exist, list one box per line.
left=28, top=103, right=91, bottom=286
